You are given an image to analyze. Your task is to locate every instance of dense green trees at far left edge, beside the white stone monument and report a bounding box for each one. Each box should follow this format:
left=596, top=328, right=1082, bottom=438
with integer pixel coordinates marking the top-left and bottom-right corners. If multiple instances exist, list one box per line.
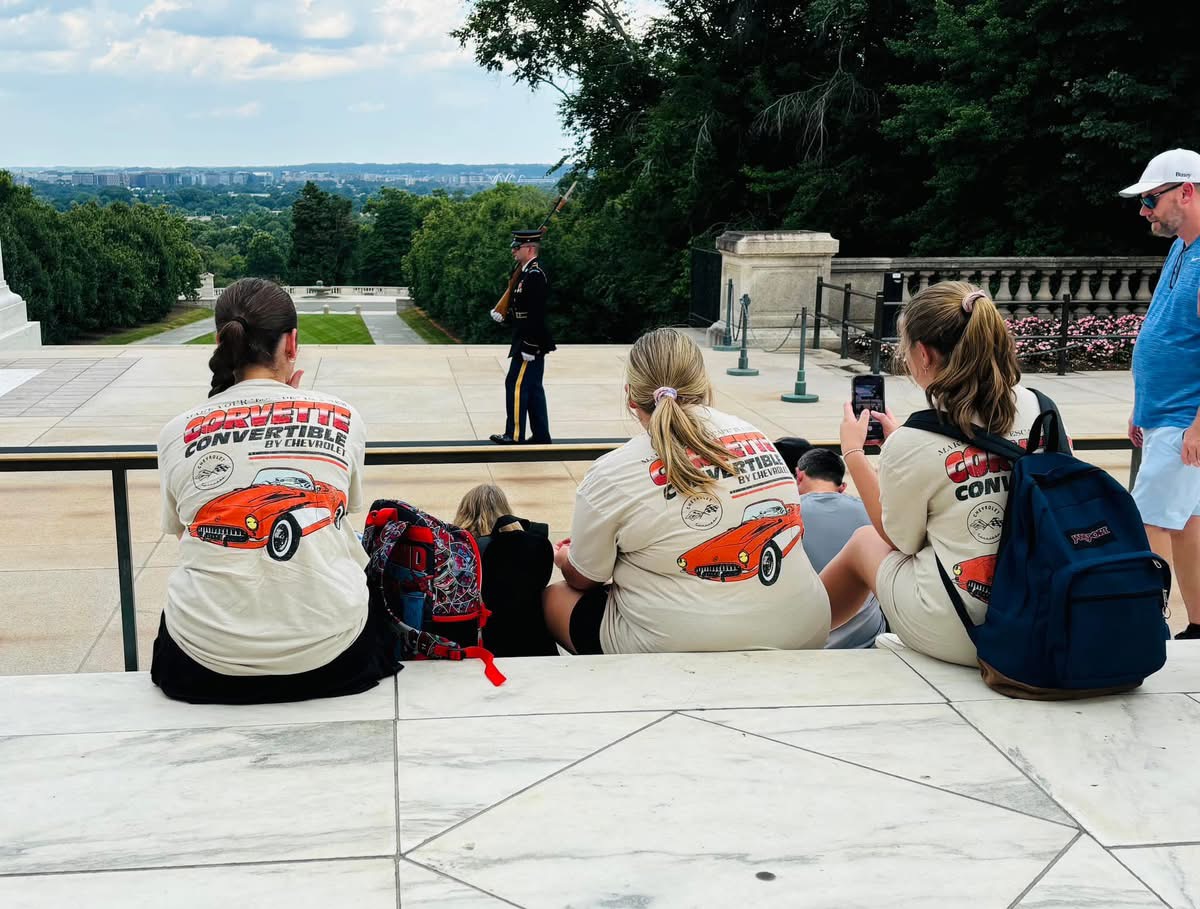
left=0, top=171, right=200, bottom=343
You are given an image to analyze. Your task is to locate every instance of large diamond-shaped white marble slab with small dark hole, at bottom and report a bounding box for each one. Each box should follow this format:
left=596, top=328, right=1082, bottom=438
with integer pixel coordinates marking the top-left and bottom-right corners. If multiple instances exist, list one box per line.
left=409, top=716, right=1075, bottom=909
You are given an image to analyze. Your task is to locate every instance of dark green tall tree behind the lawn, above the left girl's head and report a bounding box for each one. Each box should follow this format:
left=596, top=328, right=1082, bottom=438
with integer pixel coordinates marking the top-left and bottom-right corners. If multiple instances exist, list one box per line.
left=288, top=181, right=358, bottom=284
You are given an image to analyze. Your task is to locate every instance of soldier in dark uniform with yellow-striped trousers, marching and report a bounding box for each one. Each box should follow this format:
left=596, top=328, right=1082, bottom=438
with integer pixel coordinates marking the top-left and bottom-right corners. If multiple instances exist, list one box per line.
left=491, top=230, right=554, bottom=445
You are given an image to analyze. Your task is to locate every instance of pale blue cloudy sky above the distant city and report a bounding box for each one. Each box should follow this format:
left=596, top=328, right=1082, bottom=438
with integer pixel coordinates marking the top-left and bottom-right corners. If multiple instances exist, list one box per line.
left=0, top=0, right=566, bottom=167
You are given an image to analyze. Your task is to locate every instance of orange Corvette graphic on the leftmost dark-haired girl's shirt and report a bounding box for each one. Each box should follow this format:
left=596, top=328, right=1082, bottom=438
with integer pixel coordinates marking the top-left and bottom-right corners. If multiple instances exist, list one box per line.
left=187, top=468, right=346, bottom=561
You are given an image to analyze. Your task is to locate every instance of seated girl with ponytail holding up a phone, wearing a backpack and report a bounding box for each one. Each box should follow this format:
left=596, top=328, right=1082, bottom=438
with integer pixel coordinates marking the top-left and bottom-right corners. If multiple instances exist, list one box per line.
left=821, top=281, right=1065, bottom=666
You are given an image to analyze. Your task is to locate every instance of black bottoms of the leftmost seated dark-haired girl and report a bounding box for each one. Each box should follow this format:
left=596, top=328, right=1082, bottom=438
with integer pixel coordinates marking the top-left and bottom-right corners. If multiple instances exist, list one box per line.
left=150, top=609, right=402, bottom=704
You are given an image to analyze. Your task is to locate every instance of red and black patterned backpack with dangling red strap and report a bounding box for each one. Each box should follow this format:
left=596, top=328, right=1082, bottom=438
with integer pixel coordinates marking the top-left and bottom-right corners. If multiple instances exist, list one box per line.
left=362, top=499, right=504, bottom=685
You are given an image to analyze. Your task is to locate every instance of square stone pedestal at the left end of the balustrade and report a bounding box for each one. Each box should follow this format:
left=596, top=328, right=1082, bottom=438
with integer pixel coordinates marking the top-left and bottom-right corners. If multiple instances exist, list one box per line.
left=716, top=230, right=839, bottom=350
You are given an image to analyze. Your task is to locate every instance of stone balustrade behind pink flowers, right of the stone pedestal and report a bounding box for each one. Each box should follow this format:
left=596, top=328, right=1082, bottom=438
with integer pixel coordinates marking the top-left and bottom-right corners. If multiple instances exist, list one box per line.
left=830, top=257, right=1163, bottom=318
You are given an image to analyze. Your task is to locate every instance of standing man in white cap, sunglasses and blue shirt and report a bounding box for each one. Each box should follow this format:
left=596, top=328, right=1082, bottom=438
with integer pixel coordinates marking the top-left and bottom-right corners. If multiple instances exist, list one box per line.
left=1121, top=149, right=1200, bottom=639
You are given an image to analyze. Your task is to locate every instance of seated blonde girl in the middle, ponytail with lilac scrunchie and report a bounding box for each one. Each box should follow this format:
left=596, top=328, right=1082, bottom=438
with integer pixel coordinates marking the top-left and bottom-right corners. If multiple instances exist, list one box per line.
left=544, top=329, right=835, bottom=654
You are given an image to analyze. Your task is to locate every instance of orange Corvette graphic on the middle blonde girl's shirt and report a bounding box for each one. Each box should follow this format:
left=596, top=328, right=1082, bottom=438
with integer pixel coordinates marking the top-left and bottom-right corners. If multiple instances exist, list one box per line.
left=677, top=499, right=804, bottom=586
